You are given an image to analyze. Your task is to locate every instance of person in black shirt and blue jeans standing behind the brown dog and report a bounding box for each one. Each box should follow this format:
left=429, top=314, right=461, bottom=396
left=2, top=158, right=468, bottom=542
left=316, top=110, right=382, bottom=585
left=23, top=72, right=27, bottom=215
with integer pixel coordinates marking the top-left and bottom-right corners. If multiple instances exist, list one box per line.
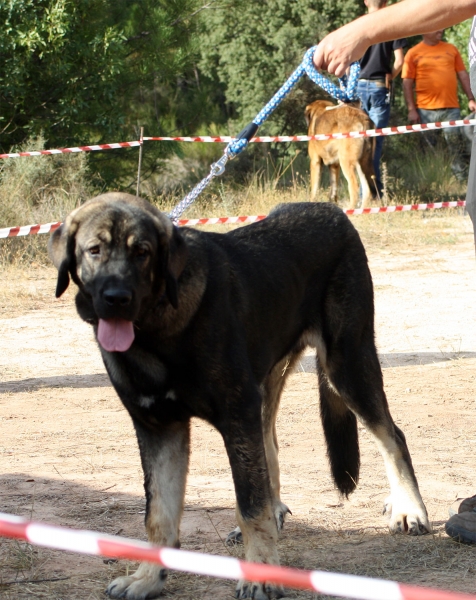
left=357, top=0, right=407, bottom=197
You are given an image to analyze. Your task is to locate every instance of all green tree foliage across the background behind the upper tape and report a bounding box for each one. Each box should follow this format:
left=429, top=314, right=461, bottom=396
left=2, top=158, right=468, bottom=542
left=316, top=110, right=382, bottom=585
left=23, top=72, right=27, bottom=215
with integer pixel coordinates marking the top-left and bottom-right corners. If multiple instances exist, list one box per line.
left=4, top=0, right=469, bottom=187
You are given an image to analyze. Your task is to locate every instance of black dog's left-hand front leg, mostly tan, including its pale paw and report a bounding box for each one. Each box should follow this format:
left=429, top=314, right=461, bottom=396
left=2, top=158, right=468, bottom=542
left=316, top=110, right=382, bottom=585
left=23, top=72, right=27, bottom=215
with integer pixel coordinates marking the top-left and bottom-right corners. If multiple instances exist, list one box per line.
left=106, top=422, right=190, bottom=600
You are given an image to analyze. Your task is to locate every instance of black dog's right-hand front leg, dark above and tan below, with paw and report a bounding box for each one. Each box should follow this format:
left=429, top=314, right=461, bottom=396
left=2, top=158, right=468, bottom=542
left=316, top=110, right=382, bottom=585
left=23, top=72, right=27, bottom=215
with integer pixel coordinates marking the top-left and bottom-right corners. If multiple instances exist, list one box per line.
left=222, top=403, right=283, bottom=600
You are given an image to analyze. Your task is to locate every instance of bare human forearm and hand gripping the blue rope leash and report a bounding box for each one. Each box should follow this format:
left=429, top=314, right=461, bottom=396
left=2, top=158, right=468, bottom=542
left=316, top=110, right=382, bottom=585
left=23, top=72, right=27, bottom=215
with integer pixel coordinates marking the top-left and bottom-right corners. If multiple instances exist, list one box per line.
left=314, top=0, right=476, bottom=77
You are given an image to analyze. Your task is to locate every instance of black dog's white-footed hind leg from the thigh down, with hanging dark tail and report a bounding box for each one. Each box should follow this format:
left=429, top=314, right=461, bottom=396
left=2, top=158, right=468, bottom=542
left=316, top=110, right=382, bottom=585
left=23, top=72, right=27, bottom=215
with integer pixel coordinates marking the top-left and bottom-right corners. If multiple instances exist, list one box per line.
left=318, top=248, right=431, bottom=535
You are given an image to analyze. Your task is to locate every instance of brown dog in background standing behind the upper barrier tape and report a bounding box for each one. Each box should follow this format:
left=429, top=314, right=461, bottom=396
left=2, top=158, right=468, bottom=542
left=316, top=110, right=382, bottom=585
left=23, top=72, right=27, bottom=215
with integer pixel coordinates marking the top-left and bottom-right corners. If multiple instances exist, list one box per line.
left=304, top=100, right=376, bottom=208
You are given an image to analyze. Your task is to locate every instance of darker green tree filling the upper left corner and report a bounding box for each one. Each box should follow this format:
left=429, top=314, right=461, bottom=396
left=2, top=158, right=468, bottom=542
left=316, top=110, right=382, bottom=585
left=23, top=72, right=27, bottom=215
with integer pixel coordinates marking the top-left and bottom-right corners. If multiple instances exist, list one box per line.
left=0, top=0, right=197, bottom=183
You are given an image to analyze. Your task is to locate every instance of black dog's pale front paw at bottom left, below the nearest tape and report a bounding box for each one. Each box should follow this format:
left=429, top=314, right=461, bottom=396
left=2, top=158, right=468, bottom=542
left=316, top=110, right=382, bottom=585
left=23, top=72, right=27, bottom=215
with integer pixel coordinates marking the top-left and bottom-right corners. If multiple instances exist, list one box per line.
left=106, top=563, right=167, bottom=600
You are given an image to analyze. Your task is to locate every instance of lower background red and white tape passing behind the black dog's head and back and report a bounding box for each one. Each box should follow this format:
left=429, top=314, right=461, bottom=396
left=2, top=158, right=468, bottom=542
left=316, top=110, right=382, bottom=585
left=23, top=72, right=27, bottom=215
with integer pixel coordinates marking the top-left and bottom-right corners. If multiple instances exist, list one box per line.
left=0, top=200, right=466, bottom=239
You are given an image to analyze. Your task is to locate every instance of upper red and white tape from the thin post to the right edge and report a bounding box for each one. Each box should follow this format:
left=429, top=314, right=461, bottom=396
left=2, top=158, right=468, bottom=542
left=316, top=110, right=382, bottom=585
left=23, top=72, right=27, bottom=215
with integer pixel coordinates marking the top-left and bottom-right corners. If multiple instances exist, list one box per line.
left=144, top=119, right=476, bottom=143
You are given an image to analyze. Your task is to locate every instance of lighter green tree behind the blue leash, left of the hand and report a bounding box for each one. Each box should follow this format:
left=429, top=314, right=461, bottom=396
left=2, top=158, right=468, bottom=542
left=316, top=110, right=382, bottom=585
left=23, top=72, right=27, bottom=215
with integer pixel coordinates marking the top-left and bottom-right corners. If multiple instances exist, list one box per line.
left=200, top=0, right=365, bottom=132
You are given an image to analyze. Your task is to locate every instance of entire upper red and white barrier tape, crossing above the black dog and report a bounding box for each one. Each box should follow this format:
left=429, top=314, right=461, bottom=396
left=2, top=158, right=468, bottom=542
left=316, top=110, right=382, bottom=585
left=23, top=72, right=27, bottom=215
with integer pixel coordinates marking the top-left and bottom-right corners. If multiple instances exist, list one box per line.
left=0, top=119, right=476, bottom=159
